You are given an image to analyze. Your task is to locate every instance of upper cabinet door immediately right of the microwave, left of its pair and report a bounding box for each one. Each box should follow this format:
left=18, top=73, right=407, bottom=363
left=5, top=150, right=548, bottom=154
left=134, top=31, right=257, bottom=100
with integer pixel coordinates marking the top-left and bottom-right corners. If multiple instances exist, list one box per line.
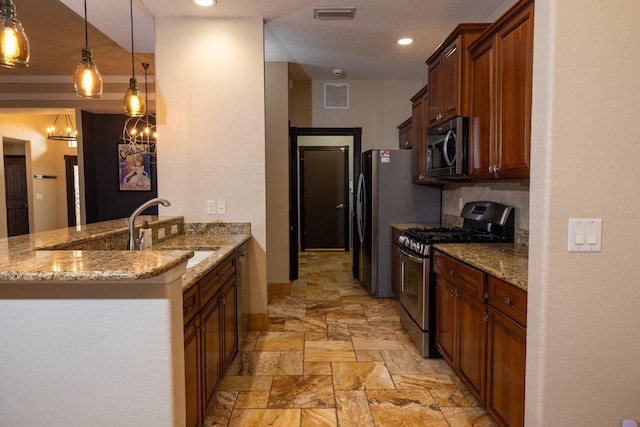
left=469, top=38, right=496, bottom=179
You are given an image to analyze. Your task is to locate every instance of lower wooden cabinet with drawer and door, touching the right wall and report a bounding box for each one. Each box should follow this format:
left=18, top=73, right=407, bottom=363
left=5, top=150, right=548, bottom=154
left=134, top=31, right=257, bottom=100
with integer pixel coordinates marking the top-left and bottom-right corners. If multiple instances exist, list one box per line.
left=486, top=276, right=527, bottom=427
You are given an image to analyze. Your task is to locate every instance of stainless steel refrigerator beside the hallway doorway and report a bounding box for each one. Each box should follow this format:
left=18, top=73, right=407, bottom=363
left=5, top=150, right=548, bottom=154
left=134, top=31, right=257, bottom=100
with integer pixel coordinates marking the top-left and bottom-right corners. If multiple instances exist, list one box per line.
left=356, top=150, right=442, bottom=298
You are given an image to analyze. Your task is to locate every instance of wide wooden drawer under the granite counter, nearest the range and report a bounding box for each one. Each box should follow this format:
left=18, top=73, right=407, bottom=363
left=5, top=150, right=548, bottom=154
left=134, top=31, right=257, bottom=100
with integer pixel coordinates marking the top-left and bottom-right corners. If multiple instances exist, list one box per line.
left=432, top=251, right=486, bottom=301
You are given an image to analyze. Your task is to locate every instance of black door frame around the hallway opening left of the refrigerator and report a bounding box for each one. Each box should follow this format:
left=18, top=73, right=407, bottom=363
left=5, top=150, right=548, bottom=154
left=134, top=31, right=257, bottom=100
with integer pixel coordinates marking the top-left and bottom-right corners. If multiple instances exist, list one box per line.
left=289, top=127, right=362, bottom=280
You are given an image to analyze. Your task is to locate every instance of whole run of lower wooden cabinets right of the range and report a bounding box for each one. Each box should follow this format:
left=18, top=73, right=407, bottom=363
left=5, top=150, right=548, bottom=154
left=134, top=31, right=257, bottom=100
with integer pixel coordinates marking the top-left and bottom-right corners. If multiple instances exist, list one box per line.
left=432, top=251, right=527, bottom=427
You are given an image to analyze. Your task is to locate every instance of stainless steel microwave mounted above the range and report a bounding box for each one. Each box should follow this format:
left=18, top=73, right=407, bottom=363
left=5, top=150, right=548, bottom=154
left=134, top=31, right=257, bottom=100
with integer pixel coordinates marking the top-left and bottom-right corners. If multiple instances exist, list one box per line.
left=427, top=117, right=469, bottom=179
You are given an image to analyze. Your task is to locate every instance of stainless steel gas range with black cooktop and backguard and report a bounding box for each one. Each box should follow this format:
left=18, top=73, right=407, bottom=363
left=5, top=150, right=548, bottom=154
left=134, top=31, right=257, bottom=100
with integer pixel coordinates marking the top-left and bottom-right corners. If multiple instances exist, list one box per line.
left=399, top=201, right=514, bottom=357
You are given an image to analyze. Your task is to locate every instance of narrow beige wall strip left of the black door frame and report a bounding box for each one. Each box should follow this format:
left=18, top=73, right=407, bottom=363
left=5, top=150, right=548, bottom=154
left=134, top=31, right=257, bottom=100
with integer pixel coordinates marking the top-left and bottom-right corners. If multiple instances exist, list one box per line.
left=265, top=62, right=289, bottom=283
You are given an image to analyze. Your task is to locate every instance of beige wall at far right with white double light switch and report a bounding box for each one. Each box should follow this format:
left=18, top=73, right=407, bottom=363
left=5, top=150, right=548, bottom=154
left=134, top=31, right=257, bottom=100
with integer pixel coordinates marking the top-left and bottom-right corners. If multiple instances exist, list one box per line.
left=526, top=0, right=640, bottom=427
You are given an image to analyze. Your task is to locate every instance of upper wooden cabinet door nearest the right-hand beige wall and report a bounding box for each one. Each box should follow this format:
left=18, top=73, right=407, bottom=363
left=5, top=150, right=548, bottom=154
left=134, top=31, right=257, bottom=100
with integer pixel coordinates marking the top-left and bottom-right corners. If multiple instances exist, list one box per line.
left=495, top=1, right=533, bottom=178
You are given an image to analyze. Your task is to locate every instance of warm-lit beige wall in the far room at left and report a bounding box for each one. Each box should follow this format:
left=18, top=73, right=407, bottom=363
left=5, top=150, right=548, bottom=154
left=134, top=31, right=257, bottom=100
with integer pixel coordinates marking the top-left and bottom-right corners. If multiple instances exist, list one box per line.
left=0, top=113, right=77, bottom=237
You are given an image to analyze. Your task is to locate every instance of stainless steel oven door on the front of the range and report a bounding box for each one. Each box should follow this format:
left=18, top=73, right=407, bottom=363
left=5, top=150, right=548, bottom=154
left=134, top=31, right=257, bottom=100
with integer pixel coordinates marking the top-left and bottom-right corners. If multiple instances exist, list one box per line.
left=398, top=250, right=429, bottom=331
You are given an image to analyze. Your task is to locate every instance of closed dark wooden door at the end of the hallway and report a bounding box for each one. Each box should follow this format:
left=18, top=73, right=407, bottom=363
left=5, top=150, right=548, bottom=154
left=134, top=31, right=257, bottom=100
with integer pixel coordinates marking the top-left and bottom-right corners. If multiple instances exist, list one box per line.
left=300, top=146, right=350, bottom=251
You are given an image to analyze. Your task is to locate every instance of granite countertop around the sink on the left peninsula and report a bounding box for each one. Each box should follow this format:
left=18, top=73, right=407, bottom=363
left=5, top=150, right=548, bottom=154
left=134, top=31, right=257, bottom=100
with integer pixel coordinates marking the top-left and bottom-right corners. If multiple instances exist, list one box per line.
left=0, top=215, right=250, bottom=288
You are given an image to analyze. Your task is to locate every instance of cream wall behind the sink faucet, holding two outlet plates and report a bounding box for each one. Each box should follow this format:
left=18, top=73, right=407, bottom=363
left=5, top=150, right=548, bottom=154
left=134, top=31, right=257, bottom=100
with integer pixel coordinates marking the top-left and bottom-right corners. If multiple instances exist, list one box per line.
left=155, top=18, right=267, bottom=314
